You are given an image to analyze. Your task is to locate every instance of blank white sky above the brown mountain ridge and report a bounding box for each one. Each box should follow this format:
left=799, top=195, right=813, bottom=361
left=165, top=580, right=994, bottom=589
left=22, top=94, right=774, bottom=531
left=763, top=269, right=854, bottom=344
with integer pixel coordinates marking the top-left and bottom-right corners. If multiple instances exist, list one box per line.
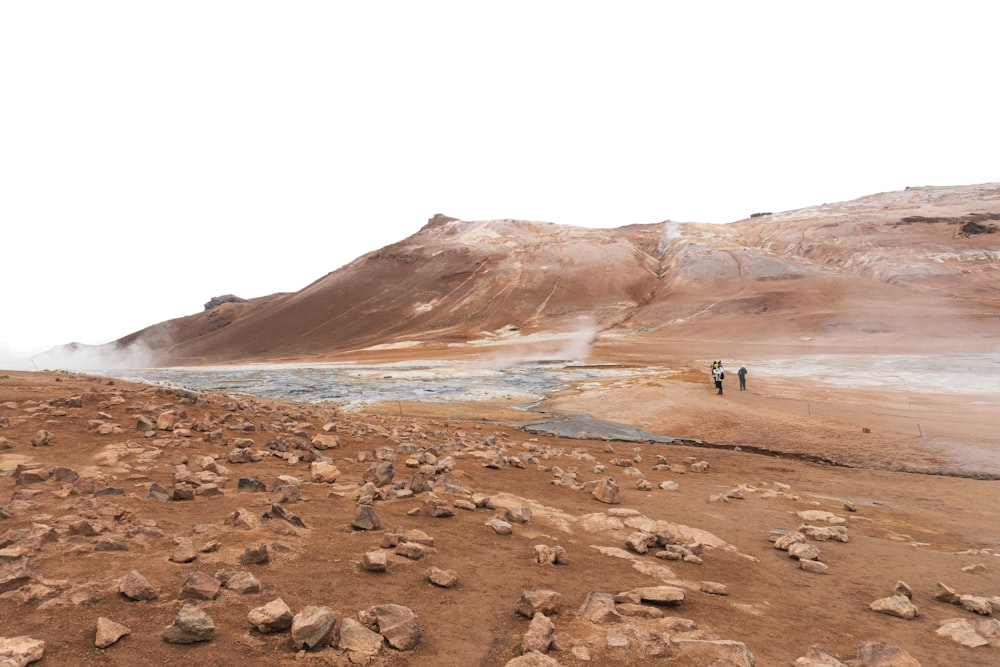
left=0, top=0, right=1000, bottom=362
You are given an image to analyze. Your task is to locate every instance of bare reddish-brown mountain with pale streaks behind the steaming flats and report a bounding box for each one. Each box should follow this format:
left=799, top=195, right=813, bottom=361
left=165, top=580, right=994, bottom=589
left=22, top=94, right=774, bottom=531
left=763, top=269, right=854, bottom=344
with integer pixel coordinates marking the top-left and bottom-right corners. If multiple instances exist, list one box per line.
left=113, top=183, right=1000, bottom=364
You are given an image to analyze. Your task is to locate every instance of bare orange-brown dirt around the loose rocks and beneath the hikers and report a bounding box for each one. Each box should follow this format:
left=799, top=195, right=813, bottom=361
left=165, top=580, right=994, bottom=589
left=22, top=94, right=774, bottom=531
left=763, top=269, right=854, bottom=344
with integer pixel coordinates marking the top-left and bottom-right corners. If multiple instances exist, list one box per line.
left=0, top=362, right=1000, bottom=666
